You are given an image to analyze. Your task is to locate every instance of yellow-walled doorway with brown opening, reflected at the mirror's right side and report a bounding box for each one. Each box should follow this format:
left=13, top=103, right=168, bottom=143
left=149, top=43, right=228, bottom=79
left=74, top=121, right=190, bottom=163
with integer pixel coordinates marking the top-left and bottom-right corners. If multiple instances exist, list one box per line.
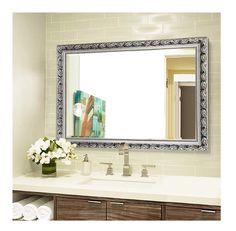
left=166, top=57, right=196, bottom=140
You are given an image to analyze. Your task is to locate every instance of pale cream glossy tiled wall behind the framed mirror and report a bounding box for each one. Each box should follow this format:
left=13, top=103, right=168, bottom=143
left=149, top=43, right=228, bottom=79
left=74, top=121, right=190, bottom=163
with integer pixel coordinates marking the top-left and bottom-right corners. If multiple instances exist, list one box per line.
left=45, top=13, right=220, bottom=176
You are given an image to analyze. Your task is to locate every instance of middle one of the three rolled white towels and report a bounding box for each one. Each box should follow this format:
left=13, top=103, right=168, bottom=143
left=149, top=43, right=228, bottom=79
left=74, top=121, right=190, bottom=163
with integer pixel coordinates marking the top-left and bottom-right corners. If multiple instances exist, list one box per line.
left=23, top=197, right=50, bottom=221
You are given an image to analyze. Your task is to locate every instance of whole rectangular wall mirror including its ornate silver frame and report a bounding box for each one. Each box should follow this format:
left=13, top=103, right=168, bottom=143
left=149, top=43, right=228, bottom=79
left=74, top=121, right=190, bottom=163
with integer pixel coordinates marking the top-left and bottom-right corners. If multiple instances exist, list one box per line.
left=57, top=38, right=208, bottom=150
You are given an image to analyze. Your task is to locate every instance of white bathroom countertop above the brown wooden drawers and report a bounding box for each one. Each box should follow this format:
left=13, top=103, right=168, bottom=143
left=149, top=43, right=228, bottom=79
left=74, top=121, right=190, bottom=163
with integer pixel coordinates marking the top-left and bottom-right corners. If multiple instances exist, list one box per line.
left=13, top=170, right=220, bottom=205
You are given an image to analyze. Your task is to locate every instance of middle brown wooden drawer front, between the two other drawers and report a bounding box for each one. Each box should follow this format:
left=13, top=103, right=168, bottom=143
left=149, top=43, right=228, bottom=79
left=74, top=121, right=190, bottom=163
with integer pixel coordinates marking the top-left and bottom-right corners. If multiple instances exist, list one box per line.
left=107, top=201, right=161, bottom=220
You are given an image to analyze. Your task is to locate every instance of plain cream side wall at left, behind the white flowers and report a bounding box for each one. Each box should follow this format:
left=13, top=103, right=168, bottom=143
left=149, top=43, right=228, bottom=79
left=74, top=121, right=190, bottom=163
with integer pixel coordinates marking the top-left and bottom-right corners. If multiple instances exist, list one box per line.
left=13, top=13, right=45, bottom=176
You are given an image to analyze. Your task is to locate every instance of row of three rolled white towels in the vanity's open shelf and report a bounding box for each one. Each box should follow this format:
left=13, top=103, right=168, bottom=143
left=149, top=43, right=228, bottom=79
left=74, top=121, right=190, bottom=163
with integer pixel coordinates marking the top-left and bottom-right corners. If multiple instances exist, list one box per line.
left=12, top=196, right=54, bottom=221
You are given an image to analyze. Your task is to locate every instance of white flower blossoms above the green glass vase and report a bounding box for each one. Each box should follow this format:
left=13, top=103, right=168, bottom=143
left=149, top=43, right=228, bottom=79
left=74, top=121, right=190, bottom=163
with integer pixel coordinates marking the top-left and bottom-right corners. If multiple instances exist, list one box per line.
left=27, top=137, right=78, bottom=165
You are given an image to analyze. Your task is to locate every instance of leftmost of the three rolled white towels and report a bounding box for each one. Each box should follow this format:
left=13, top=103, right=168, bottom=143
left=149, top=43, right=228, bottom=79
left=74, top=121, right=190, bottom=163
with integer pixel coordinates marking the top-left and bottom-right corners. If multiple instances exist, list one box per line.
left=12, top=196, right=40, bottom=219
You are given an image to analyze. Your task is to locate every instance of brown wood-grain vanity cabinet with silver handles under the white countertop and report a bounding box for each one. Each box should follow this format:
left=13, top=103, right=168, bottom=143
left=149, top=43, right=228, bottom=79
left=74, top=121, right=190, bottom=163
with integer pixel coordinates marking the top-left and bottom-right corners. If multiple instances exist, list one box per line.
left=14, top=191, right=221, bottom=220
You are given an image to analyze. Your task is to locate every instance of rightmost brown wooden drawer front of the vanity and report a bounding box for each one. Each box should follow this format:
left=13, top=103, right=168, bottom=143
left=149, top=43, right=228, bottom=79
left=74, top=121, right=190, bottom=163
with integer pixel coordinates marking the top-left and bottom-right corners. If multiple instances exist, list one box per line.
left=165, top=206, right=220, bottom=220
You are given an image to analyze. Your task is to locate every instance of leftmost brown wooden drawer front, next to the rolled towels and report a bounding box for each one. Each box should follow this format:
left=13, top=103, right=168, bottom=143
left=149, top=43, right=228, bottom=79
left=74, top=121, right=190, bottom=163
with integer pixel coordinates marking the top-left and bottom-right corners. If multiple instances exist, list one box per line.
left=56, top=197, right=106, bottom=220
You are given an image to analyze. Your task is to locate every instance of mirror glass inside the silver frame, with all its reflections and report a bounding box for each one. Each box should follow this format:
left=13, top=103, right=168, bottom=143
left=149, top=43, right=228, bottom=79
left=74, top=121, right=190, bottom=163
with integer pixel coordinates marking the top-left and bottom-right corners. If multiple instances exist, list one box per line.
left=65, top=48, right=197, bottom=140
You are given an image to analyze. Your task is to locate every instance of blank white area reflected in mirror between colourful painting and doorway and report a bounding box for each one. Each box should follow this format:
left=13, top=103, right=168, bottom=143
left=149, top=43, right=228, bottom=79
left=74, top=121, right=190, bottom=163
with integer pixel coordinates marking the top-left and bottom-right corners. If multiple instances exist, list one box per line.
left=80, top=51, right=165, bottom=139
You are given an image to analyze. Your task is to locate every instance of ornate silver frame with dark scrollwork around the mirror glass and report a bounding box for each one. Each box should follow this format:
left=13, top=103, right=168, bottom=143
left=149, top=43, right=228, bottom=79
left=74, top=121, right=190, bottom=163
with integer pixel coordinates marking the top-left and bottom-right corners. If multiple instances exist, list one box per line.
left=56, top=37, right=208, bottom=151
